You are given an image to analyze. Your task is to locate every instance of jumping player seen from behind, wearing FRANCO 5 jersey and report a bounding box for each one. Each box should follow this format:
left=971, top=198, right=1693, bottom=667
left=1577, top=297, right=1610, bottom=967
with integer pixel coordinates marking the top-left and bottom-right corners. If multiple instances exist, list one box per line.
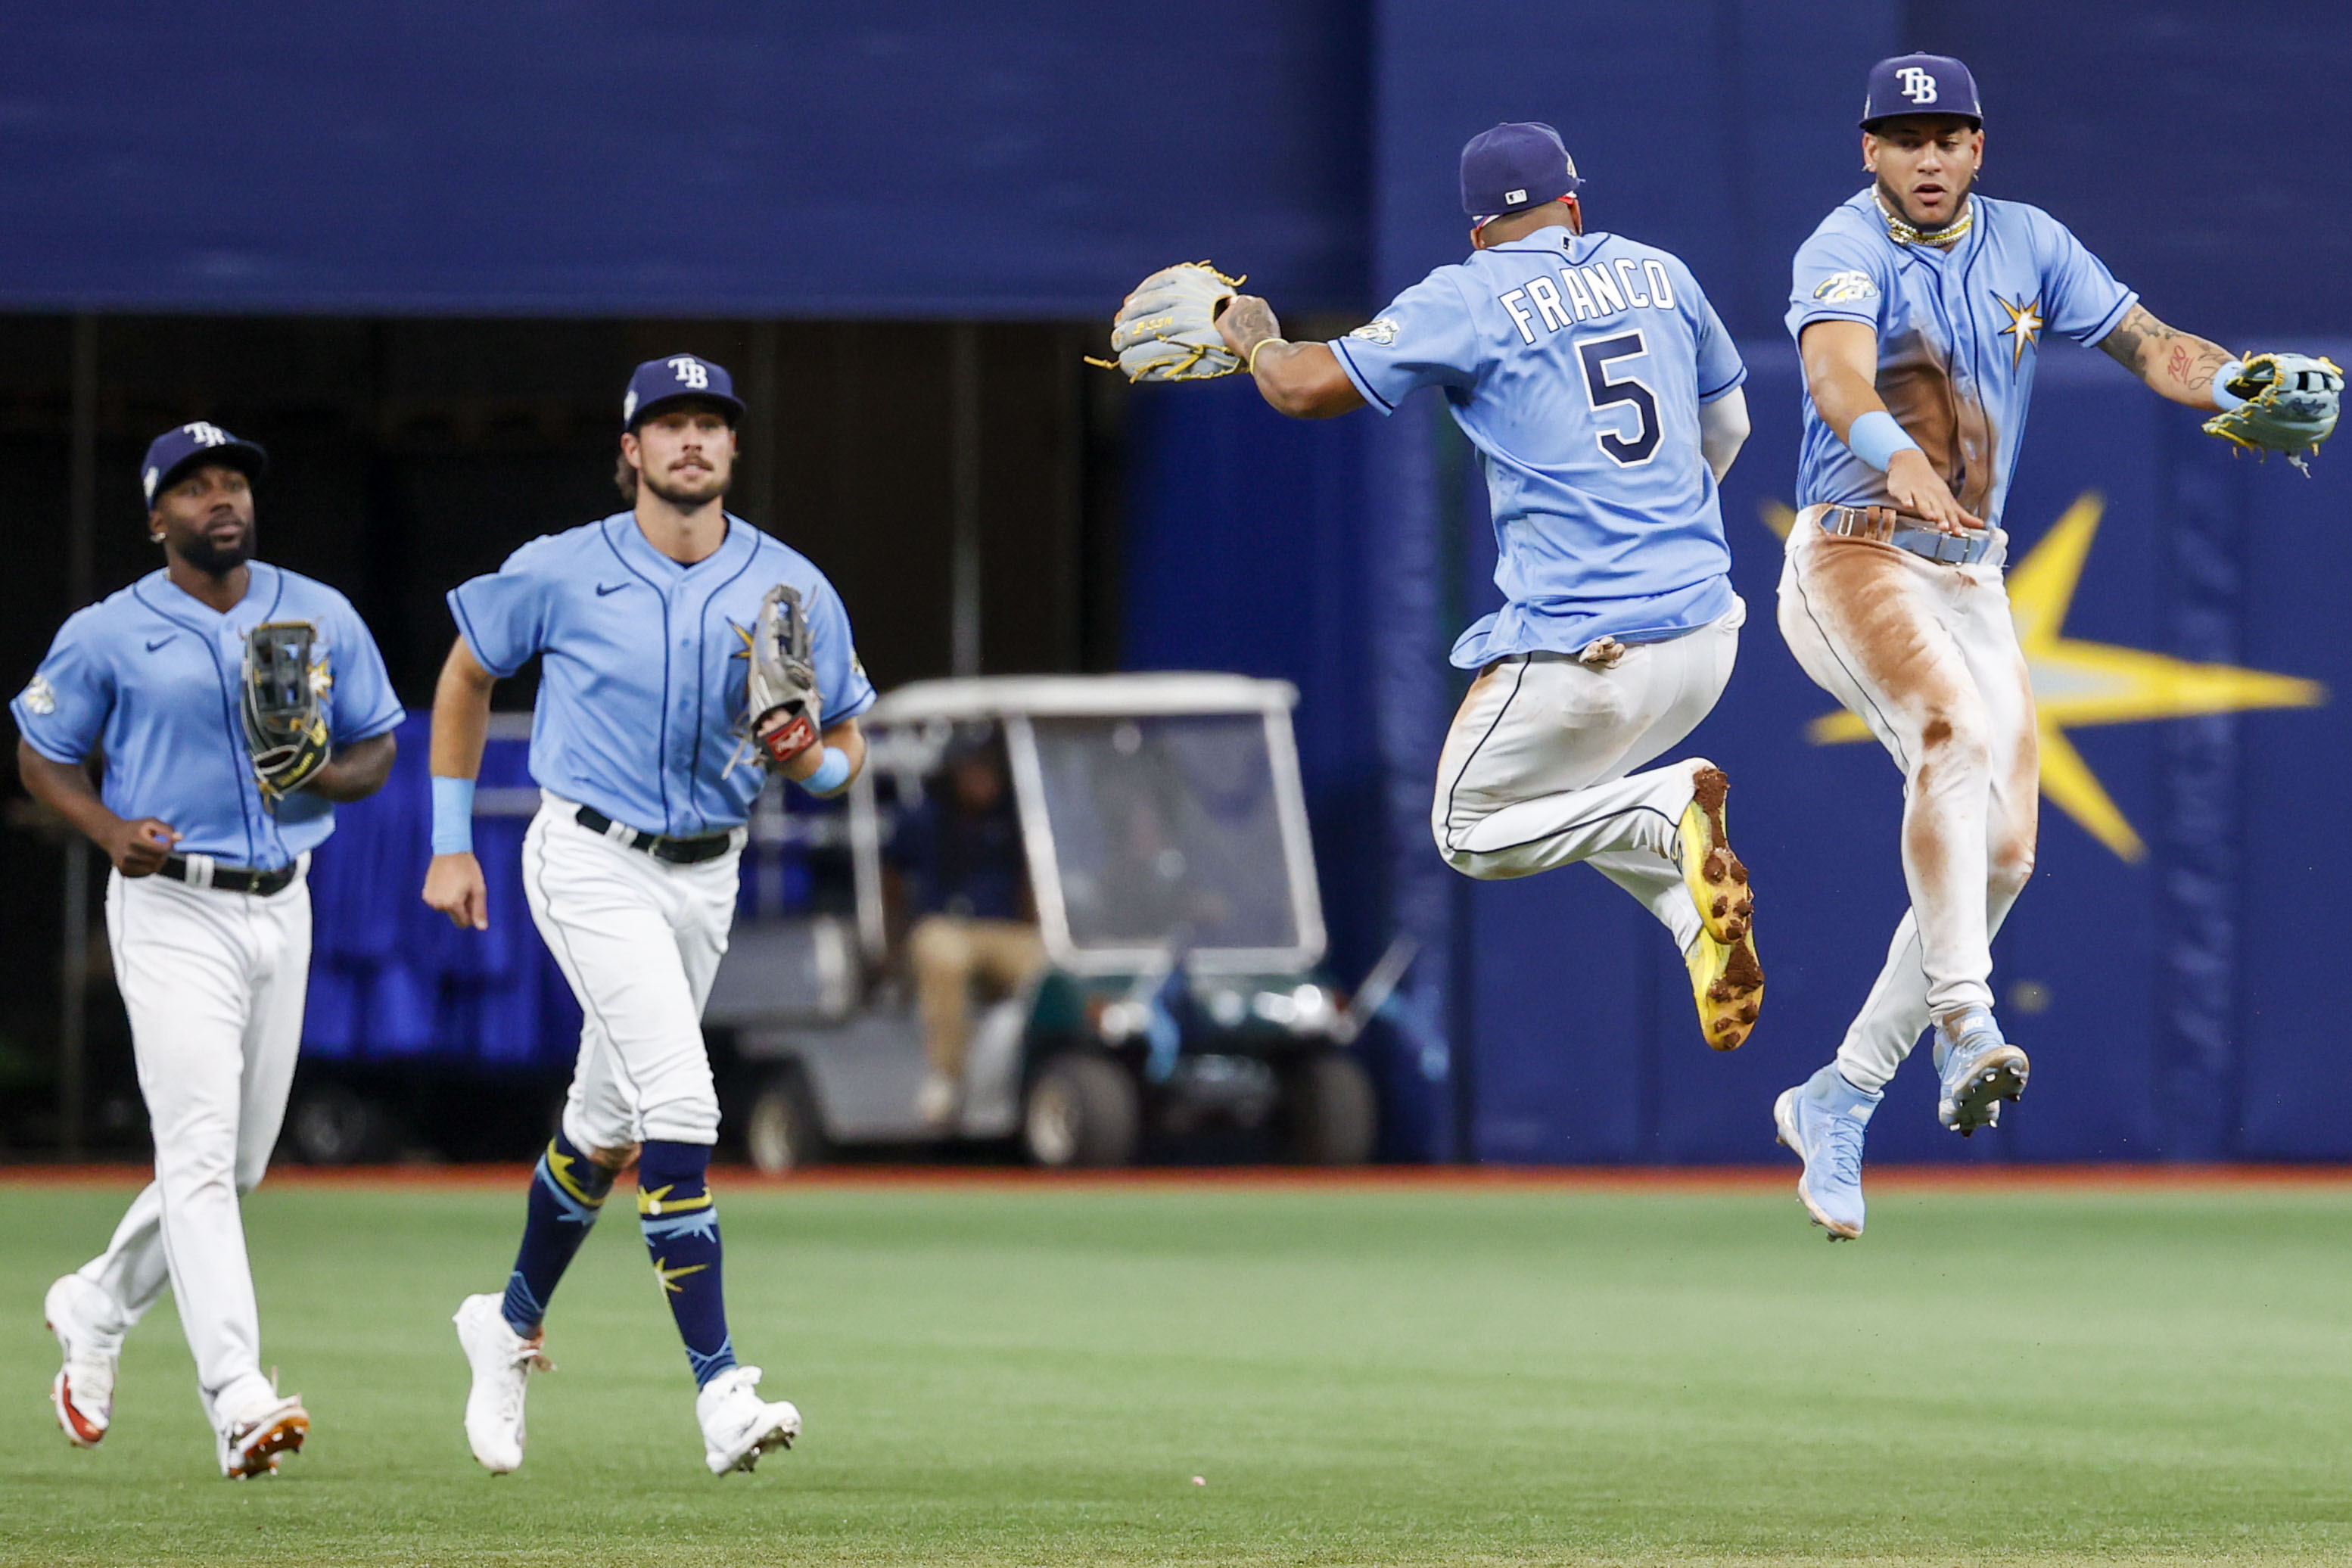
left=1112, top=123, right=1764, bottom=1051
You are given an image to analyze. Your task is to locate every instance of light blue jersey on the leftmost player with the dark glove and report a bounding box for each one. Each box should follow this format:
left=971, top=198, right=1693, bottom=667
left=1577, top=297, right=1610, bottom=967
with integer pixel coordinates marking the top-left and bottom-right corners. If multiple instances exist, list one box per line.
left=9, top=562, right=405, bottom=870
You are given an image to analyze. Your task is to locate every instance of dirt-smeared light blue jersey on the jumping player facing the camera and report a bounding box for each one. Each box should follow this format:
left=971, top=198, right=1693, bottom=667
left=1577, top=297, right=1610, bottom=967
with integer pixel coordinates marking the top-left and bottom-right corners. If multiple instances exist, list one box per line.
left=1787, top=191, right=2138, bottom=527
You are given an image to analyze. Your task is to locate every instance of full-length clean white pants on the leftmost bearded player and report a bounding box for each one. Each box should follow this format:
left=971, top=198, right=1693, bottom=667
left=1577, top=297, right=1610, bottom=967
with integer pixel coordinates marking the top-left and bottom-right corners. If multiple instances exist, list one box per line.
left=80, top=865, right=310, bottom=1427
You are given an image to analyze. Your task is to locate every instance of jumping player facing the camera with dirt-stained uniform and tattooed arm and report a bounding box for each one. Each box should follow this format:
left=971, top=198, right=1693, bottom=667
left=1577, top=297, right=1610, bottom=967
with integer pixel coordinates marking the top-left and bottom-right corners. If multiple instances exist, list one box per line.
left=1773, top=54, right=2343, bottom=1239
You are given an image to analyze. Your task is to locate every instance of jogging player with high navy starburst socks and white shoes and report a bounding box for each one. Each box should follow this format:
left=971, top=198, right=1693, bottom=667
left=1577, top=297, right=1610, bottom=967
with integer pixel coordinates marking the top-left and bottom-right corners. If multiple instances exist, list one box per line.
left=423, top=355, right=875, bottom=1474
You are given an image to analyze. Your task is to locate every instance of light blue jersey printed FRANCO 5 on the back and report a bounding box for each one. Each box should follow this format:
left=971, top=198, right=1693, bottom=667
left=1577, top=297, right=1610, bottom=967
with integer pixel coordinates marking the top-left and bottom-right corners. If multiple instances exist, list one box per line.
left=1331, top=228, right=1747, bottom=670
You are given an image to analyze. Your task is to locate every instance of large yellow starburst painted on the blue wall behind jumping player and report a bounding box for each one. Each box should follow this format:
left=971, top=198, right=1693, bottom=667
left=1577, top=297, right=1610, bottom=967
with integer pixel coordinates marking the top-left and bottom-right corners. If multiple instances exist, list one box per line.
left=1764, top=491, right=2329, bottom=860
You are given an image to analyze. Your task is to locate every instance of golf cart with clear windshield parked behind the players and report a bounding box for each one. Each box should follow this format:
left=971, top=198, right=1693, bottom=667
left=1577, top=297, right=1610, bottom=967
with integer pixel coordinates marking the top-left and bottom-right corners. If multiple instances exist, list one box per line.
left=703, top=675, right=1409, bottom=1171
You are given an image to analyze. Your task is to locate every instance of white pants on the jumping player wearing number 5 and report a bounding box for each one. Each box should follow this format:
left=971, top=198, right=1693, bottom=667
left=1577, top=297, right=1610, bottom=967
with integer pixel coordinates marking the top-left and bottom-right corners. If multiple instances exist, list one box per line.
left=1430, top=604, right=1747, bottom=952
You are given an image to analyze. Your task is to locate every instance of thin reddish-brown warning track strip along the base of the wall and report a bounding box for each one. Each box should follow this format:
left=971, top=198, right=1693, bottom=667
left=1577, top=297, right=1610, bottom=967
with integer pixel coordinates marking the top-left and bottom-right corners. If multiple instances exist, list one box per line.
left=0, top=1162, right=2352, bottom=1194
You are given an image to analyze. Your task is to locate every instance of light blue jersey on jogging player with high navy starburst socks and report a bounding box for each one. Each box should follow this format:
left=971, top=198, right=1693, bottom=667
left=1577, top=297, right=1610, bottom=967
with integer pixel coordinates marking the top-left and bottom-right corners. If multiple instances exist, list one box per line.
left=450, top=512, right=875, bottom=837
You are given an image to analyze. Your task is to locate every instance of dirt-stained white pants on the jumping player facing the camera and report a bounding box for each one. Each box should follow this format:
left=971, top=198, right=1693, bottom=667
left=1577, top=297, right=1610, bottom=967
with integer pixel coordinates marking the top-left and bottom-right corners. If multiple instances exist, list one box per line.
left=1781, top=506, right=2042, bottom=1090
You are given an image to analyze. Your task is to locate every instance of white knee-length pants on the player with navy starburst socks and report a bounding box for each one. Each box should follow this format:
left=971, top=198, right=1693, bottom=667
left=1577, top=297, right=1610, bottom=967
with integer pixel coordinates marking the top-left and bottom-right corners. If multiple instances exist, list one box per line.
left=522, top=792, right=745, bottom=1150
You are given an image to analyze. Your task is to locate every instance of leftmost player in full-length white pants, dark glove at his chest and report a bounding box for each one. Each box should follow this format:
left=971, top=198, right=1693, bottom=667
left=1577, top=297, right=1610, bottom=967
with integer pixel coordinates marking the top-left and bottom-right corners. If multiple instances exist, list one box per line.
left=9, top=423, right=402, bottom=1476
